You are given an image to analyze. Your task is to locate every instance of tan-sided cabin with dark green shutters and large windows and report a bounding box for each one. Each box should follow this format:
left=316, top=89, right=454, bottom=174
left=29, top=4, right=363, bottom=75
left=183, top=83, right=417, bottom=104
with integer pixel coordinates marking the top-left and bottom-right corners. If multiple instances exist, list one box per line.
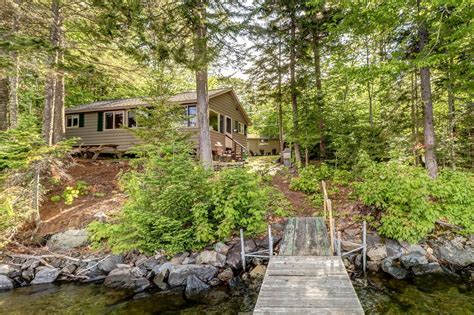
left=65, top=88, right=251, bottom=160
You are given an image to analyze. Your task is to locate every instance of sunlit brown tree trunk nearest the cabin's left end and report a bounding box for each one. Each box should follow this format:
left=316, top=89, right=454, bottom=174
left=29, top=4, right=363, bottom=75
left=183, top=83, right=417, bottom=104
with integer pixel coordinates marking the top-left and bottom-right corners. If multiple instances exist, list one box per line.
left=43, top=0, right=60, bottom=145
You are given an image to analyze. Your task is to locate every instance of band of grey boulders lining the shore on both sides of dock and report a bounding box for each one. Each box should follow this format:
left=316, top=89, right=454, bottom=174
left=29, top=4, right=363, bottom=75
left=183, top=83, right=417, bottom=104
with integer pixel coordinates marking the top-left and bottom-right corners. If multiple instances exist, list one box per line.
left=0, top=227, right=474, bottom=299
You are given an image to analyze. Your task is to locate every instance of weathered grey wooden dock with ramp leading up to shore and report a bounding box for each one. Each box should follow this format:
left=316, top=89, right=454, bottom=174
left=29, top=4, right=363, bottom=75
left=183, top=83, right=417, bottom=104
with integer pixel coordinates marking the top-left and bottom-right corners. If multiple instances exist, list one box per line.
left=254, top=217, right=364, bottom=314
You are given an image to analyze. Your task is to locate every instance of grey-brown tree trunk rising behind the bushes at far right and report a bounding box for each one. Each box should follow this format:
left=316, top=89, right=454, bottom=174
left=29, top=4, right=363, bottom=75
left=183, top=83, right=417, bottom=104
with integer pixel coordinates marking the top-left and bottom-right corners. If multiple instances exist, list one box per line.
left=418, top=0, right=438, bottom=178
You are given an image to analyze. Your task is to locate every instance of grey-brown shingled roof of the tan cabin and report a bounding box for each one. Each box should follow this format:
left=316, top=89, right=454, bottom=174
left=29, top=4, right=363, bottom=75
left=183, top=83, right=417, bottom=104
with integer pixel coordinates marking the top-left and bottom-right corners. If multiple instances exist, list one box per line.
left=66, top=88, right=232, bottom=114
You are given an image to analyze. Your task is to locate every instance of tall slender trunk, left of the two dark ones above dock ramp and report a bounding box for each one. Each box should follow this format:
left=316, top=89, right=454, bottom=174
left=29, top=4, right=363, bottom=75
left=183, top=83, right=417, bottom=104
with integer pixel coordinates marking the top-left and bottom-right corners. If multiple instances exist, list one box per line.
left=290, top=12, right=301, bottom=167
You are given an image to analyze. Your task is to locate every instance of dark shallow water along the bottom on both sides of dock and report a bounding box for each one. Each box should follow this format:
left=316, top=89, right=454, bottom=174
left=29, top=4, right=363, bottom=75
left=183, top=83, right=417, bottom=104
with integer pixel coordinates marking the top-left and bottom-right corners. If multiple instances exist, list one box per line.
left=0, top=276, right=474, bottom=315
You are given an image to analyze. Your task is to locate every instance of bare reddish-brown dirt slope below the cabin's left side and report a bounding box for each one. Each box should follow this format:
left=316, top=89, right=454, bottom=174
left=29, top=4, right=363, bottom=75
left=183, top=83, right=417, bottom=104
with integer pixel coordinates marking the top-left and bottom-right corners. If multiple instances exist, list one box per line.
left=38, top=159, right=128, bottom=236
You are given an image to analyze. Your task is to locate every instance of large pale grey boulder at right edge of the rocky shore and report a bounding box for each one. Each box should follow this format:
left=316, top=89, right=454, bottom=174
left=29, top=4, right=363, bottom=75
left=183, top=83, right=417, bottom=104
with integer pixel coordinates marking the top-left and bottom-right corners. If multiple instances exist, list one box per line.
left=430, top=236, right=474, bottom=267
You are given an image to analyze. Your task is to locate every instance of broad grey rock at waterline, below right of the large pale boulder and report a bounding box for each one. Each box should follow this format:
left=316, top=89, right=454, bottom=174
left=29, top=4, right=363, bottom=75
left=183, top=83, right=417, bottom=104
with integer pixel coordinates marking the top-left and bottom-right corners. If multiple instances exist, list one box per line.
left=104, top=267, right=151, bottom=292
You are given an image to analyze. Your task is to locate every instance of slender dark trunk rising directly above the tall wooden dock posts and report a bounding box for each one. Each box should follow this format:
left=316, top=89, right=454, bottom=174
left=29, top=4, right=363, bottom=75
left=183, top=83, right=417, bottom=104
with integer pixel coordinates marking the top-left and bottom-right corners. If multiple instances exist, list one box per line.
left=313, top=28, right=326, bottom=160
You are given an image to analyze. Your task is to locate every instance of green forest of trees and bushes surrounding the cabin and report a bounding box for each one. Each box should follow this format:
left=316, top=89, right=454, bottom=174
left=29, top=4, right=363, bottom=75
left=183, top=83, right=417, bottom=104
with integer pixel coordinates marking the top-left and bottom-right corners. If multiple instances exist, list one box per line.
left=0, top=0, right=474, bottom=262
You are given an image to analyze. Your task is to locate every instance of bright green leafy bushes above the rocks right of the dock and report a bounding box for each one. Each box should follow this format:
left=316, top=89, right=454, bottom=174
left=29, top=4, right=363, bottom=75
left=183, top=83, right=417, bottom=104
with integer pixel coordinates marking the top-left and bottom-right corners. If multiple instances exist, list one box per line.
left=355, top=162, right=474, bottom=243
